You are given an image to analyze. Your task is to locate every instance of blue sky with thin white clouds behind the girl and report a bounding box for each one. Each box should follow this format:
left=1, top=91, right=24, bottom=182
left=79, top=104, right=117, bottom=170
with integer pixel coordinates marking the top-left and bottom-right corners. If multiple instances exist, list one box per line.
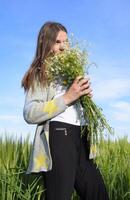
left=0, top=0, right=130, bottom=139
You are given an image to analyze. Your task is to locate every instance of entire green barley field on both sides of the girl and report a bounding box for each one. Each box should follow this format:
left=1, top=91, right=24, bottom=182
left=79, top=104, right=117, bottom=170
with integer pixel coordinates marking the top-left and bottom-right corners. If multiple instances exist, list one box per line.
left=0, top=137, right=130, bottom=200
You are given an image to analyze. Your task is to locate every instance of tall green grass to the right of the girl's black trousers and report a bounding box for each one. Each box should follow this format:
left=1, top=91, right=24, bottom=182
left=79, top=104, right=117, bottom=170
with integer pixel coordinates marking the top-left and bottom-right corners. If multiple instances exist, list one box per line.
left=97, top=137, right=130, bottom=200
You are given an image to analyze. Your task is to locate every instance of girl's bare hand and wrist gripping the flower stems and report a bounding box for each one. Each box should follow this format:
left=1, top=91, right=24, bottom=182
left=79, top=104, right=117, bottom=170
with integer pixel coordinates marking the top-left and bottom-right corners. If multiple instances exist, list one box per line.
left=63, top=76, right=92, bottom=105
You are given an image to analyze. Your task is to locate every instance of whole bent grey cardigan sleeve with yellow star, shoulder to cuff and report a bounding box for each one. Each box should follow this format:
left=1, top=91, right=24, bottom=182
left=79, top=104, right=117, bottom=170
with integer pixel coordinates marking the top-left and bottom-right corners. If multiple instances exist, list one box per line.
left=23, top=84, right=67, bottom=124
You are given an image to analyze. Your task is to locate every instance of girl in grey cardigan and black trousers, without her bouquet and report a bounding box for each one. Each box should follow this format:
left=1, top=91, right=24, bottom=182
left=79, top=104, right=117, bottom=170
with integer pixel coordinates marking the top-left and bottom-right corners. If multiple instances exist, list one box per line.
left=22, top=22, right=108, bottom=200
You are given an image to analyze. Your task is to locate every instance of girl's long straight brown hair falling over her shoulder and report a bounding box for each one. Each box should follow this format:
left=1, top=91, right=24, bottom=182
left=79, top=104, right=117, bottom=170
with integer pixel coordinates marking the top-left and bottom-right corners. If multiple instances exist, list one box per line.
left=22, top=22, right=67, bottom=91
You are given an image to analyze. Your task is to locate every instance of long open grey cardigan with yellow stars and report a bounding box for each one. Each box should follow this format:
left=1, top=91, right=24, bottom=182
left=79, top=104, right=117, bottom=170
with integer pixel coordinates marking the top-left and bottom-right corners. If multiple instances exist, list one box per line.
left=23, top=83, right=67, bottom=174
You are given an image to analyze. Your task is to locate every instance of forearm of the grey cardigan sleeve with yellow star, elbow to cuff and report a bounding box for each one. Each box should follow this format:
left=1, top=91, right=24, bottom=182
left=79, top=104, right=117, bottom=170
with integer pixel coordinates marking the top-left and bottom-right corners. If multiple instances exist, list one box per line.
left=23, top=96, right=66, bottom=124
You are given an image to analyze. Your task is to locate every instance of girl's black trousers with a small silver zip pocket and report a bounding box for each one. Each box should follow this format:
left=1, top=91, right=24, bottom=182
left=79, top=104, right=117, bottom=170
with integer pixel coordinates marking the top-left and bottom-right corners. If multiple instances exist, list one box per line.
left=43, top=121, right=109, bottom=200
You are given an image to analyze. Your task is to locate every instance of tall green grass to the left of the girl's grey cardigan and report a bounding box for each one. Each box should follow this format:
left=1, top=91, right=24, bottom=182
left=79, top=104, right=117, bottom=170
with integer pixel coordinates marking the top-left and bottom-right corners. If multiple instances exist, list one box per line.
left=0, top=138, right=44, bottom=200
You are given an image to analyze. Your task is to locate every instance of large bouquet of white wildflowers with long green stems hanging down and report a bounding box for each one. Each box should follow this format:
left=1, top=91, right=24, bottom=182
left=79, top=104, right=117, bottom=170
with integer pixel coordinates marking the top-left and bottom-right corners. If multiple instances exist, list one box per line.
left=46, top=43, right=112, bottom=147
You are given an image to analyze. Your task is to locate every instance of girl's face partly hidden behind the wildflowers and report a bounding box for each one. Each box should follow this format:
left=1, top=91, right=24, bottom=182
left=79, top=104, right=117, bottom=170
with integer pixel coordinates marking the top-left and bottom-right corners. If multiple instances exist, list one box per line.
left=51, top=31, right=68, bottom=53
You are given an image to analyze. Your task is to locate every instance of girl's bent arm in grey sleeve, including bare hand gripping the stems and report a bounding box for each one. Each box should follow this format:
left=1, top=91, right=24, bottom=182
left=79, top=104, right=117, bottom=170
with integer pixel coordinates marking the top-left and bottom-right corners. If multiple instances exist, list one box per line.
left=23, top=76, right=92, bottom=124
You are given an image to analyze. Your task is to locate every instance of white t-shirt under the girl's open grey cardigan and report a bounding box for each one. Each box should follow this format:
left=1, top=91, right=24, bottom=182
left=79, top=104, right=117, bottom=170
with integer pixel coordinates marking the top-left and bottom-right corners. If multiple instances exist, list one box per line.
left=51, top=85, right=86, bottom=126
